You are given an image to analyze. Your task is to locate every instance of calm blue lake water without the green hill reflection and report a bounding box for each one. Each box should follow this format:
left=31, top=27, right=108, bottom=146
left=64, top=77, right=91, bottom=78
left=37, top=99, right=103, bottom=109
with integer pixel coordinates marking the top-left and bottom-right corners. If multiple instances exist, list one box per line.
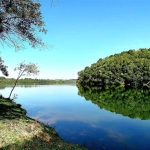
left=0, top=85, right=150, bottom=150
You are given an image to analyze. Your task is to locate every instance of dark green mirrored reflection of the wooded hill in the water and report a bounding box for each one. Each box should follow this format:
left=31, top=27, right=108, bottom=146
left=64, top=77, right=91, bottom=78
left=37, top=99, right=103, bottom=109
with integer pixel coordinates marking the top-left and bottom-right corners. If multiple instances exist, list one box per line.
left=78, top=86, right=150, bottom=120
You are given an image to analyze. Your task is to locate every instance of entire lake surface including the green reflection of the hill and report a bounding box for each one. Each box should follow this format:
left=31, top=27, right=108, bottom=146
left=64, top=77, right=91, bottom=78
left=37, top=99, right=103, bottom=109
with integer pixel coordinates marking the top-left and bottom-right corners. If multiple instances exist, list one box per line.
left=0, top=85, right=150, bottom=150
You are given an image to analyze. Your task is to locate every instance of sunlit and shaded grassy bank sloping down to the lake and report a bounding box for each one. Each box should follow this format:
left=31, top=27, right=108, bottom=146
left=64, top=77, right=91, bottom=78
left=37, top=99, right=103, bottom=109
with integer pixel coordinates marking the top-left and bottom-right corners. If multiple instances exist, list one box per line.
left=0, top=98, right=86, bottom=150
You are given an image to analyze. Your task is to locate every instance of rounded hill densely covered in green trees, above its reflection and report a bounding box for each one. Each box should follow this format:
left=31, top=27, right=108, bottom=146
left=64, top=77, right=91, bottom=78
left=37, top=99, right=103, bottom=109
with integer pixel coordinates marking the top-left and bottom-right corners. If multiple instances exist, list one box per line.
left=77, top=49, right=150, bottom=87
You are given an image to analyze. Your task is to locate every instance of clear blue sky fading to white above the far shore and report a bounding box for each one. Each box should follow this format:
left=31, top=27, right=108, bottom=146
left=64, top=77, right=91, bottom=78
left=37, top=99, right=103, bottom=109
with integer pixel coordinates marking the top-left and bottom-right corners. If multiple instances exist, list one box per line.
left=0, top=0, right=150, bottom=79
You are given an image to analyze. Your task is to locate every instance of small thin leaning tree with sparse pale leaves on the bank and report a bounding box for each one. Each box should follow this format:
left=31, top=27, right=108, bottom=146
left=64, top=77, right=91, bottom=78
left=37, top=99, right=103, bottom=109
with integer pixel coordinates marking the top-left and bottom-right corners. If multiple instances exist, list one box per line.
left=8, top=62, right=39, bottom=99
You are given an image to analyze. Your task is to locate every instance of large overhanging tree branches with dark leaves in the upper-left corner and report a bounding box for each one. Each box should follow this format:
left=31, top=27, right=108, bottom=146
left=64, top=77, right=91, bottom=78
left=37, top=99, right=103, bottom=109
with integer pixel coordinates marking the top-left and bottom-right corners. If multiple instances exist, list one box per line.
left=0, top=0, right=47, bottom=51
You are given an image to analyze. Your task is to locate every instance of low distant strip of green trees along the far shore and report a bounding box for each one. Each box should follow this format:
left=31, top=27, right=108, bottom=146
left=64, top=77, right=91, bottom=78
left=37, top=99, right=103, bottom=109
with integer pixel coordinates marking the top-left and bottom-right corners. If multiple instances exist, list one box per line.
left=0, top=77, right=76, bottom=85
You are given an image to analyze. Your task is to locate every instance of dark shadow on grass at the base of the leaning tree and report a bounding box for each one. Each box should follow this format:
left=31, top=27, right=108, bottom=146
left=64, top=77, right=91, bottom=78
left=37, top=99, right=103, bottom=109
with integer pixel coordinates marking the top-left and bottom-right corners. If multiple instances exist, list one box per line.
left=0, top=98, right=26, bottom=120
